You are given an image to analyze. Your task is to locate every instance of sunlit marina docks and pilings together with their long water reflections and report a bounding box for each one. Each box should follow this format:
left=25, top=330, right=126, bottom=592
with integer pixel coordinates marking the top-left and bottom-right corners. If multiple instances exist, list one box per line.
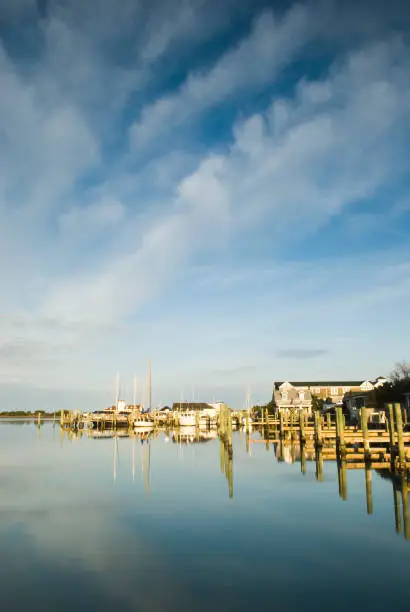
left=55, top=404, right=410, bottom=528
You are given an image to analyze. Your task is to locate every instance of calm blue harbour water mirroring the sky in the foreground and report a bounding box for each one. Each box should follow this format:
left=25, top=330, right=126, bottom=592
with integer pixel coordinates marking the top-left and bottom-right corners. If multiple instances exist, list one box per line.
left=0, top=422, right=410, bottom=612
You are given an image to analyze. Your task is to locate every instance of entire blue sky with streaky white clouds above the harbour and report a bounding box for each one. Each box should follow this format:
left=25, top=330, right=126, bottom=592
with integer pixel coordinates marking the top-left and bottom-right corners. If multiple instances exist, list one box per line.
left=0, top=0, right=410, bottom=410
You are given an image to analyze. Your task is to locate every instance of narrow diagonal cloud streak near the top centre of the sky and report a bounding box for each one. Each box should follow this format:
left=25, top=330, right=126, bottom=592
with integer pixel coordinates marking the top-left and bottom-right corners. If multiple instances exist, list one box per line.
left=131, top=5, right=314, bottom=147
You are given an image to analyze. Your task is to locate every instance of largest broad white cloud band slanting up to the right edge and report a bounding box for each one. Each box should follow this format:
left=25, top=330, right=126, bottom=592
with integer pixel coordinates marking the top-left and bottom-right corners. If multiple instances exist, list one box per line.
left=41, top=35, right=410, bottom=328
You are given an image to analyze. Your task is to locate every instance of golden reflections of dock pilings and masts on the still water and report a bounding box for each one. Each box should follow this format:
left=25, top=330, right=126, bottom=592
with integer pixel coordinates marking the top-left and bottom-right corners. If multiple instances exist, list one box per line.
left=52, top=422, right=410, bottom=540
